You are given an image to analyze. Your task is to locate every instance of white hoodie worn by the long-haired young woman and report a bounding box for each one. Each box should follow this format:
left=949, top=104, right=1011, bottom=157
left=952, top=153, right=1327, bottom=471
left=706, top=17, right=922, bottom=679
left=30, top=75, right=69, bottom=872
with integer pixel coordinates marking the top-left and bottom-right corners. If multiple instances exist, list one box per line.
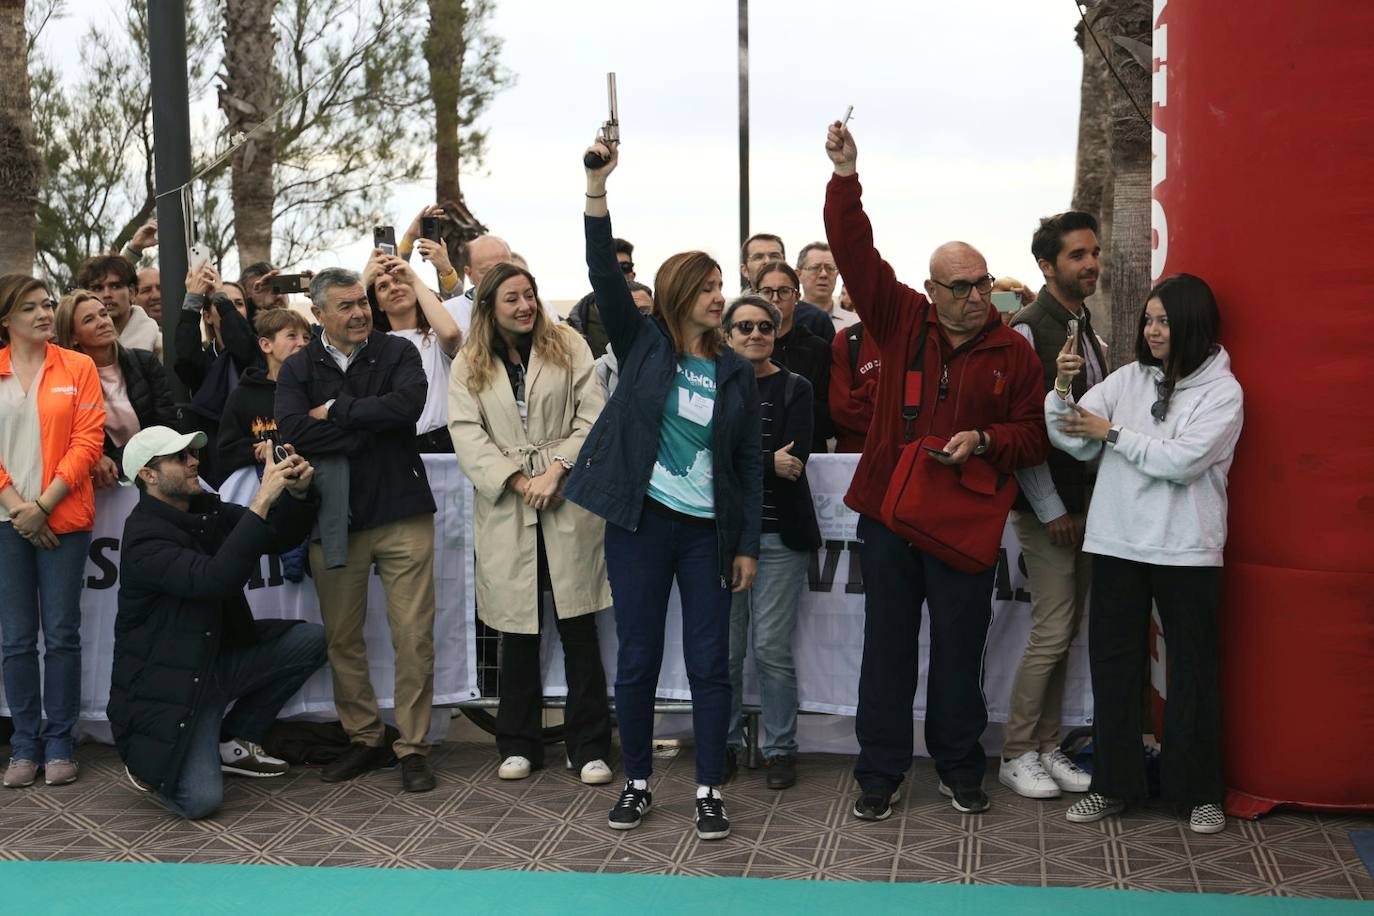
left=1044, top=347, right=1242, bottom=566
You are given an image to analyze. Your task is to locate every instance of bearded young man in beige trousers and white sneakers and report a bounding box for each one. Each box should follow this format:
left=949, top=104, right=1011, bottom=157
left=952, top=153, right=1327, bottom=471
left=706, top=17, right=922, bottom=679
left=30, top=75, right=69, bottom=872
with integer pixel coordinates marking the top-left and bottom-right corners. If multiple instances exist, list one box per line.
left=998, top=210, right=1106, bottom=798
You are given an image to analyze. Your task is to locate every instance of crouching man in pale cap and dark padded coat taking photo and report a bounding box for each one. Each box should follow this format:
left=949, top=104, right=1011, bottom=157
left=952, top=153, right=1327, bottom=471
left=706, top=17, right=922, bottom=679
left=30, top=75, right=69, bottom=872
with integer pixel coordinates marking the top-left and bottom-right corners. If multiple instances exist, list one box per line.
left=107, top=426, right=326, bottom=818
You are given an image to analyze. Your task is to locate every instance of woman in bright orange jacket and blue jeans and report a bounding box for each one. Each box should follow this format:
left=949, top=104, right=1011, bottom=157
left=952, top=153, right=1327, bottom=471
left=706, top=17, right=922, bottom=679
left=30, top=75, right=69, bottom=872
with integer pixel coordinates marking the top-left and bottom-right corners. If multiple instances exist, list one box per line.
left=0, top=273, right=105, bottom=788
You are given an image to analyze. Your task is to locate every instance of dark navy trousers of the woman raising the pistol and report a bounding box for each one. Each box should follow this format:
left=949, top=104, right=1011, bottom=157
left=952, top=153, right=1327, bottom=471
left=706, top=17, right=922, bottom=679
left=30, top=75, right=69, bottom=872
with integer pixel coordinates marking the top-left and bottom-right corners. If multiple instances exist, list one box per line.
left=606, top=509, right=730, bottom=786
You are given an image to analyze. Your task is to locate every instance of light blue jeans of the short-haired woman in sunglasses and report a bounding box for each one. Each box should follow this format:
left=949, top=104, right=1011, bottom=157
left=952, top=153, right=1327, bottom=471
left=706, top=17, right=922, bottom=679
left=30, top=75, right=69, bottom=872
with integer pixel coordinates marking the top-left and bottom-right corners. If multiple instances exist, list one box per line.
left=730, top=534, right=807, bottom=757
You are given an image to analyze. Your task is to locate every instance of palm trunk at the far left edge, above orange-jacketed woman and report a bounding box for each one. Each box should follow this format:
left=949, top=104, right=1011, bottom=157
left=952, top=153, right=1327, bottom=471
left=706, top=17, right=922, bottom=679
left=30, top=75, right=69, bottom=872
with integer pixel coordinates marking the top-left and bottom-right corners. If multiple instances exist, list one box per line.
left=0, top=0, right=41, bottom=273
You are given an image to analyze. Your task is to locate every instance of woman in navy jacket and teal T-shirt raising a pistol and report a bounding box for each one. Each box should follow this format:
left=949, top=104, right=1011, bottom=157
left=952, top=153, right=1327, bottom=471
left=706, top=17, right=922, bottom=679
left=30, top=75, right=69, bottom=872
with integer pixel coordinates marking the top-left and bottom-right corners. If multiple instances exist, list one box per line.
left=567, top=132, right=763, bottom=839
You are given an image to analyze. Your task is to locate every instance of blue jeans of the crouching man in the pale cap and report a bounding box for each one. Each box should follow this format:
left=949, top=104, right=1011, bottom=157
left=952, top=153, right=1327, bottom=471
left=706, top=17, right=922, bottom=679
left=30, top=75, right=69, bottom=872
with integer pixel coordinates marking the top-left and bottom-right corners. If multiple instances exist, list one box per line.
left=161, top=621, right=326, bottom=820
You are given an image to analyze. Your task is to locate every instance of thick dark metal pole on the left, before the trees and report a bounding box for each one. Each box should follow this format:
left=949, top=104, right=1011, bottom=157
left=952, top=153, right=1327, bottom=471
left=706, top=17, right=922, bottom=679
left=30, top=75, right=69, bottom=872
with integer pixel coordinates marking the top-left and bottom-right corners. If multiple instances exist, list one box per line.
left=148, top=0, right=191, bottom=404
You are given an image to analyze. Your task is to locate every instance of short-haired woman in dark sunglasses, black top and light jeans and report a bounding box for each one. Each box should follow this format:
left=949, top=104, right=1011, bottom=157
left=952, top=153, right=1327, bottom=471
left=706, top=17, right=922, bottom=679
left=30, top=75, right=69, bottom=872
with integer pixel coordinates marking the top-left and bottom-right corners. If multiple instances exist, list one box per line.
left=721, top=295, right=820, bottom=788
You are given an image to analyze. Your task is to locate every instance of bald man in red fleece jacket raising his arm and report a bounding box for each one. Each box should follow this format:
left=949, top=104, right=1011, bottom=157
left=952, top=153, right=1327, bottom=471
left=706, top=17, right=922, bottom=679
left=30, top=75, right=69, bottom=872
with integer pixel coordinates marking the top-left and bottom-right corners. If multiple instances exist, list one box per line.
left=826, top=121, right=1050, bottom=820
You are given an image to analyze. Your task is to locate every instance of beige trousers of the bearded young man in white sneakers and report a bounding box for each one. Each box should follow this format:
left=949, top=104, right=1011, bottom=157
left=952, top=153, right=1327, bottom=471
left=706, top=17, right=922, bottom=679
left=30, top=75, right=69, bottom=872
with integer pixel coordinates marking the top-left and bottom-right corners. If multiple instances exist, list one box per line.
left=1002, top=512, right=1092, bottom=759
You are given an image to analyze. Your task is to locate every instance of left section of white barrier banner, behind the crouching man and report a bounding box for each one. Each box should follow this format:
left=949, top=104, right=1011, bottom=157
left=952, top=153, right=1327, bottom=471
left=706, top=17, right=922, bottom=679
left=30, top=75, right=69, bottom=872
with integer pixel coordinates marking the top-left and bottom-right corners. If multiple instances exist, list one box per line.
left=0, top=455, right=477, bottom=733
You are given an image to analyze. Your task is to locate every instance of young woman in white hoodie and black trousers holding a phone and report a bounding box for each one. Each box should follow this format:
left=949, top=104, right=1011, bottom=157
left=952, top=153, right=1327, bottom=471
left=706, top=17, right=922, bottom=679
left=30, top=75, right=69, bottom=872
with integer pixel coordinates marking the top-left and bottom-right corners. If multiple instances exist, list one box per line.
left=1044, top=273, right=1242, bottom=834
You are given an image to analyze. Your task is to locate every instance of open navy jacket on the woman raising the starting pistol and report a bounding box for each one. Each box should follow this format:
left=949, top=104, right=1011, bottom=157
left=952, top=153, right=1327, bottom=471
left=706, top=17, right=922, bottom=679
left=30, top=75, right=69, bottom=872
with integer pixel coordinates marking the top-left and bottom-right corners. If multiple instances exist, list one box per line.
left=565, top=216, right=764, bottom=582
